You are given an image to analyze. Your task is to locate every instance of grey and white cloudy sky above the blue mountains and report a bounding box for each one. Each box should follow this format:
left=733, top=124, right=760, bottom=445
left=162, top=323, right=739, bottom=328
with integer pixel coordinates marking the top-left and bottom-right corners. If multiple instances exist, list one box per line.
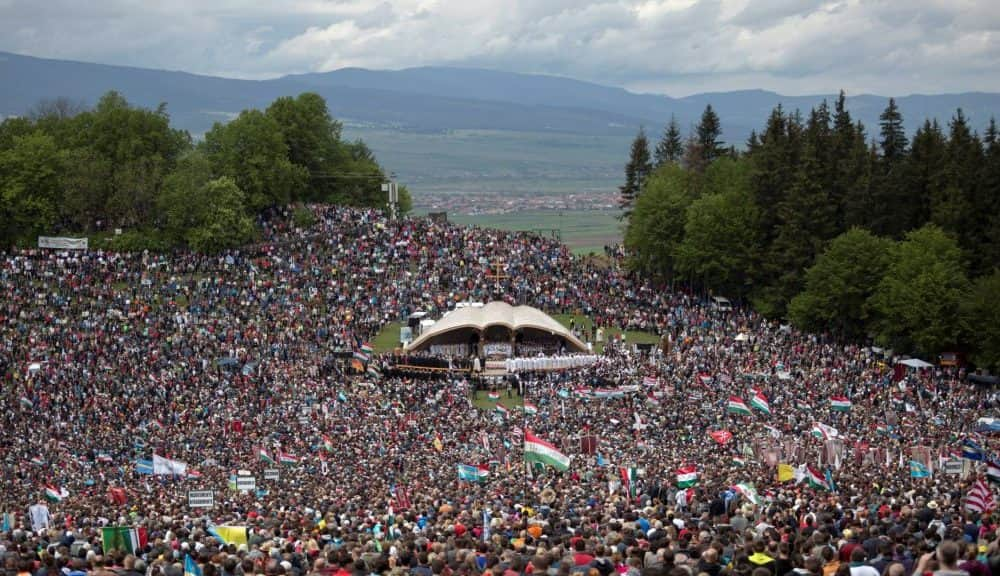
left=0, top=0, right=1000, bottom=96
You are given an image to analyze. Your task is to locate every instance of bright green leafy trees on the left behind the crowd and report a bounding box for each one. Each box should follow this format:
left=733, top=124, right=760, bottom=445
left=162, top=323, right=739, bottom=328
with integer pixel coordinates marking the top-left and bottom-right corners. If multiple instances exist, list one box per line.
left=0, top=92, right=410, bottom=252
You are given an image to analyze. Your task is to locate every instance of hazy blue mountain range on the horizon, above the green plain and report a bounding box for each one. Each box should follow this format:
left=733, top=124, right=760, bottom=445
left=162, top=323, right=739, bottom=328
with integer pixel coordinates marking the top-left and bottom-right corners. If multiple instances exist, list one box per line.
left=7, top=52, right=1000, bottom=139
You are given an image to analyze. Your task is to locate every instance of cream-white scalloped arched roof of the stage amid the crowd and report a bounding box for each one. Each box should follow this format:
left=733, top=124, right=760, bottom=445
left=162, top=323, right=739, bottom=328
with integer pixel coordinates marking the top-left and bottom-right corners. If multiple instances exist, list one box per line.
left=406, top=302, right=587, bottom=351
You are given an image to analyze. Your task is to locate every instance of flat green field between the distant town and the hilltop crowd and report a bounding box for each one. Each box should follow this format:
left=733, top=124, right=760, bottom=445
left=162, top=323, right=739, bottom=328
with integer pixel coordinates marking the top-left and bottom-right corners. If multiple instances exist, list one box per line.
left=448, top=210, right=622, bottom=255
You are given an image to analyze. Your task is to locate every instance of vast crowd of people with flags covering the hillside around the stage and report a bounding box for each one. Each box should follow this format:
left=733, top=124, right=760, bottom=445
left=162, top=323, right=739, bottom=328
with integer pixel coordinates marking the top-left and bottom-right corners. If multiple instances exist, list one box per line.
left=0, top=206, right=1000, bottom=576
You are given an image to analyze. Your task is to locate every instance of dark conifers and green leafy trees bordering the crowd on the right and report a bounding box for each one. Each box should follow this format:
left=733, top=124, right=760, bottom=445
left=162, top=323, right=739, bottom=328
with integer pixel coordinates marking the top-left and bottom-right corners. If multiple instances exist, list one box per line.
left=620, top=93, right=1000, bottom=368
